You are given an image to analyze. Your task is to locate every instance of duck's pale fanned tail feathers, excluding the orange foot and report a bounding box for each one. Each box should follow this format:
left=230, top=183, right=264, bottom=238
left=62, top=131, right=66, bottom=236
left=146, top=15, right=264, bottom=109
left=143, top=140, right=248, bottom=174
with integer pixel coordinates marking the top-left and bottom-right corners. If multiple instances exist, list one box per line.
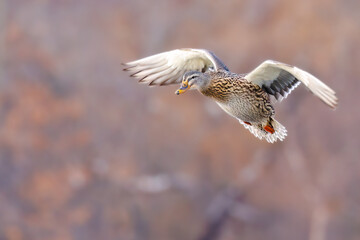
left=239, top=119, right=287, bottom=143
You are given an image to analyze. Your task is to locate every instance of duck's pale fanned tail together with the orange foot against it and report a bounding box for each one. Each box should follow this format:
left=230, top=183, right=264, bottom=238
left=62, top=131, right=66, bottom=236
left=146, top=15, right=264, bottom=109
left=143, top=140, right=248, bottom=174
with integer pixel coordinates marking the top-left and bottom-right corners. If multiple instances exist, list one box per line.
left=239, top=118, right=287, bottom=143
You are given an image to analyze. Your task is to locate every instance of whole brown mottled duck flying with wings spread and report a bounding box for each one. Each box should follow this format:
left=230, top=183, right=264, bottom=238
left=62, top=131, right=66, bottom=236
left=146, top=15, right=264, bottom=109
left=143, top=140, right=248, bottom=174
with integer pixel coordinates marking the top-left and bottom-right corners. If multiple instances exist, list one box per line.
left=123, top=48, right=338, bottom=143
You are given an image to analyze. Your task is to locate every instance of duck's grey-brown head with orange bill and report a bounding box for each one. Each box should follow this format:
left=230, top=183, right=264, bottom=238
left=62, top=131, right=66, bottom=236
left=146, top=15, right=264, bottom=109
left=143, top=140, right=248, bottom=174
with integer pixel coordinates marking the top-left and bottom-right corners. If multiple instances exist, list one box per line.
left=175, top=71, right=208, bottom=95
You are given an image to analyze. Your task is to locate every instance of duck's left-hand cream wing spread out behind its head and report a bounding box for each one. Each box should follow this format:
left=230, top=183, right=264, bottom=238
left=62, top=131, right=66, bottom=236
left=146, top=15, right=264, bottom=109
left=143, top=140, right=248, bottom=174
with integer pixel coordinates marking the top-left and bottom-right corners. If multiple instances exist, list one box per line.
left=124, top=48, right=228, bottom=86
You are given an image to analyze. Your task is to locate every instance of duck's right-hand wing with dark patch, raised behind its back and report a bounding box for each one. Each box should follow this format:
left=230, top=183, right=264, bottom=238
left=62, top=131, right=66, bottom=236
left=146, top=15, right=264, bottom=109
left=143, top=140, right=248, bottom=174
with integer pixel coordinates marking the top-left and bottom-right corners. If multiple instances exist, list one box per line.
left=245, top=60, right=338, bottom=108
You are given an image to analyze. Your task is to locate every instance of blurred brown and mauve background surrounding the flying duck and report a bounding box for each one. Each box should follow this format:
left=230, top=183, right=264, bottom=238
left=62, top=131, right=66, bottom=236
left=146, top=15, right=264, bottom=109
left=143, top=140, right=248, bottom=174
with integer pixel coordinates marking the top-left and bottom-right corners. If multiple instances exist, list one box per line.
left=0, top=0, right=360, bottom=240
